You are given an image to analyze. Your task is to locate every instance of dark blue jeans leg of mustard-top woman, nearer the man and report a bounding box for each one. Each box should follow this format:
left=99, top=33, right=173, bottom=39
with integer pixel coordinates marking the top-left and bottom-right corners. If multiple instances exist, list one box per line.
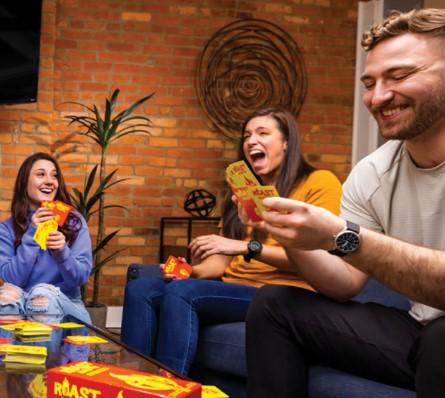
left=156, top=279, right=257, bottom=375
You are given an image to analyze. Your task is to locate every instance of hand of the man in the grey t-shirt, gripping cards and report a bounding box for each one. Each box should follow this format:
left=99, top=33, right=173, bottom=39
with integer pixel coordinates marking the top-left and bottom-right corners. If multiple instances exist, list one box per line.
left=262, top=197, right=345, bottom=250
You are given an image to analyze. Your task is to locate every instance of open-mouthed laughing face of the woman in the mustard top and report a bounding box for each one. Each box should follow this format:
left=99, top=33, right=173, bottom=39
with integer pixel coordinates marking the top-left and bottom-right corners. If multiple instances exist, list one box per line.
left=243, top=116, right=287, bottom=185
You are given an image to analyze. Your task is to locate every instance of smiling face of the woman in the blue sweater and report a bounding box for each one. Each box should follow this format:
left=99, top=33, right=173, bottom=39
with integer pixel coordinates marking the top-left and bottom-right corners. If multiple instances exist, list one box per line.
left=26, top=159, right=59, bottom=208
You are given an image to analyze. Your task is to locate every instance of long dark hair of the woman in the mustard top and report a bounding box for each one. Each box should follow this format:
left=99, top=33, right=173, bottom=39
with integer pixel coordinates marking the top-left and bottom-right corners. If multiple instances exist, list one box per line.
left=222, top=108, right=315, bottom=239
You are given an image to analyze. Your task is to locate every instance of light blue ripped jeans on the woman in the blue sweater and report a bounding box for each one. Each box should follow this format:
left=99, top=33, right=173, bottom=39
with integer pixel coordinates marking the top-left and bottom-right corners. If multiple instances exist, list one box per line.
left=0, top=283, right=91, bottom=323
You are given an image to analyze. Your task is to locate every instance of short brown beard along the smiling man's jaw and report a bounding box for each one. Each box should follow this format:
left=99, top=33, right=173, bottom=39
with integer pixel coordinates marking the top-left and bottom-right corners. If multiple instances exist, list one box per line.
left=379, top=81, right=445, bottom=140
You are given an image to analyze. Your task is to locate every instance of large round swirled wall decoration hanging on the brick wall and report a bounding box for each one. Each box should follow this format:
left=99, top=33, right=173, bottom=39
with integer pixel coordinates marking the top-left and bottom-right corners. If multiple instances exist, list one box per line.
left=195, top=19, right=307, bottom=138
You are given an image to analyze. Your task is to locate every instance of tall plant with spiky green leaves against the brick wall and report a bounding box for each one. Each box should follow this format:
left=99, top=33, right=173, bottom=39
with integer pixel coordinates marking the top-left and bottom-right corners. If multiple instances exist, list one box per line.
left=66, top=89, right=154, bottom=322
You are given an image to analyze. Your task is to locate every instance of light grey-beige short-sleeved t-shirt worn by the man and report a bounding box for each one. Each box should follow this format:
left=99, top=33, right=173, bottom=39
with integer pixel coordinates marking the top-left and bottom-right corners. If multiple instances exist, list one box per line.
left=341, top=140, right=445, bottom=323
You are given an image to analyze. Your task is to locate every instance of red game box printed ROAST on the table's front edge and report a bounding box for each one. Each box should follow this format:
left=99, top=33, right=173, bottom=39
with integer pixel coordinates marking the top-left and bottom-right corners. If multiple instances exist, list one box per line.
left=47, top=361, right=201, bottom=398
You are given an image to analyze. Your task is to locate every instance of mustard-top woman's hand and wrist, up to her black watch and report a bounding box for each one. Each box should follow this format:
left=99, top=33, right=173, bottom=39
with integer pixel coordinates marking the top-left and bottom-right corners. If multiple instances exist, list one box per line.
left=189, top=235, right=247, bottom=260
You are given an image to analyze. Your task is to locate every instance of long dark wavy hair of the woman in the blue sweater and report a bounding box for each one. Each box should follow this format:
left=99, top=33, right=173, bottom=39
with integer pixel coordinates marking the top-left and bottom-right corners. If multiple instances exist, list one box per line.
left=11, top=152, right=81, bottom=248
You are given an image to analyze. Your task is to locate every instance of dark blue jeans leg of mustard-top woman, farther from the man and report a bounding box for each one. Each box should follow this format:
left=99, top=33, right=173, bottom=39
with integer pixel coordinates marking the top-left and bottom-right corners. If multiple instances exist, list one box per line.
left=121, top=277, right=168, bottom=355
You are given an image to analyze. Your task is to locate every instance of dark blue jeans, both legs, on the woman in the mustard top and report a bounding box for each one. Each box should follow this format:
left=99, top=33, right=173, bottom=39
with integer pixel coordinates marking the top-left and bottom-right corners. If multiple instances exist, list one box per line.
left=121, top=277, right=257, bottom=375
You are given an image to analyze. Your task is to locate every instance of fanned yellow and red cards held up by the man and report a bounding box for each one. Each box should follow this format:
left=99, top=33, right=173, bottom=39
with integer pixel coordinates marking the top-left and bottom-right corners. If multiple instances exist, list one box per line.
left=226, top=160, right=279, bottom=222
